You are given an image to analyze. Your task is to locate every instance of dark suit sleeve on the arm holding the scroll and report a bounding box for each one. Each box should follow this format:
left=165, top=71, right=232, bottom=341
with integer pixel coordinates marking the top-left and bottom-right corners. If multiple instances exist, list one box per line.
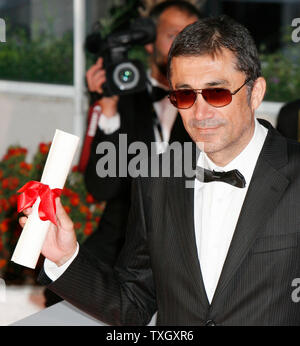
left=40, top=178, right=157, bottom=325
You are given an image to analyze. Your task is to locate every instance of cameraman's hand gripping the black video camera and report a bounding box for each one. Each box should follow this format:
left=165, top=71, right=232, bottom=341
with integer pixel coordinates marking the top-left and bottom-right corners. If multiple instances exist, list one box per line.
left=86, top=57, right=119, bottom=118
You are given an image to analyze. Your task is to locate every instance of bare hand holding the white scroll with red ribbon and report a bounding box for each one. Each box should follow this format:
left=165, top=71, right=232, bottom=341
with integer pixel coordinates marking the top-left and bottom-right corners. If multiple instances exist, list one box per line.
left=19, top=198, right=77, bottom=266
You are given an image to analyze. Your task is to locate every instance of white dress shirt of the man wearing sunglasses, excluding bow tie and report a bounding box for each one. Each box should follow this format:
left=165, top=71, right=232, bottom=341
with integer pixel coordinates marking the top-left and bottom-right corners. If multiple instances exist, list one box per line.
left=194, top=119, right=268, bottom=302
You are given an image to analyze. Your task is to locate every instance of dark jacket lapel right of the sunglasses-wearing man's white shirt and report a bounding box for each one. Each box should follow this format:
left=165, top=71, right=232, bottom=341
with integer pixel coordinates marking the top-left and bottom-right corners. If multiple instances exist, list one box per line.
left=212, top=129, right=289, bottom=306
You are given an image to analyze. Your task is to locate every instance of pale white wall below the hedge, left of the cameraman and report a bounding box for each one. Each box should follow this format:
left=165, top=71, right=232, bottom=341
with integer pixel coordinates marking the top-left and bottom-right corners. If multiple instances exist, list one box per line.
left=0, top=88, right=88, bottom=163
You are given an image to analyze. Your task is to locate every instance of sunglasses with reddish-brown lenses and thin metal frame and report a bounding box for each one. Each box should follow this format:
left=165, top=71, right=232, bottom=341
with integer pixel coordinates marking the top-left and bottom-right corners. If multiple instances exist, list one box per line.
left=169, top=78, right=250, bottom=109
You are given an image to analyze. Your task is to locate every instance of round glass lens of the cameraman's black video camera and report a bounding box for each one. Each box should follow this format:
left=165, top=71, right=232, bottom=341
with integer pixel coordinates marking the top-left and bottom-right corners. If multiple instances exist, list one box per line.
left=113, top=62, right=140, bottom=90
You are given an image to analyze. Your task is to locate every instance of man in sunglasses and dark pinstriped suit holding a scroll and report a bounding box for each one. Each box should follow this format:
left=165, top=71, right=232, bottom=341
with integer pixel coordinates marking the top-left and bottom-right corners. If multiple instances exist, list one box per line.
left=20, top=16, right=300, bottom=326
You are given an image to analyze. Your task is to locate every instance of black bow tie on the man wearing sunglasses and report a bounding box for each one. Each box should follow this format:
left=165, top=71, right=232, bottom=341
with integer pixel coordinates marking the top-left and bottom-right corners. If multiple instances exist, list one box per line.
left=196, top=167, right=246, bottom=188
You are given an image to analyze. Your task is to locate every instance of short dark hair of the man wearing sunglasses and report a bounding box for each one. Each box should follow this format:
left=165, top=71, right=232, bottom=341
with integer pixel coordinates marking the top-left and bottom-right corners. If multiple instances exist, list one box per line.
left=168, top=15, right=261, bottom=87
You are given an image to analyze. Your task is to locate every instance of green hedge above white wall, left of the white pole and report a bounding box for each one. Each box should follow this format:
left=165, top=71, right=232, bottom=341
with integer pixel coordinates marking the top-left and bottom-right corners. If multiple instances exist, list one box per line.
left=0, top=25, right=73, bottom=85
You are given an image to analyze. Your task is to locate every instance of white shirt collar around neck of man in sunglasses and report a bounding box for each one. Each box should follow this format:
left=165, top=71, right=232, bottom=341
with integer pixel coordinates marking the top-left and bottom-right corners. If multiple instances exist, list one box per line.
left=197, top=119, right=268, bottom=187
